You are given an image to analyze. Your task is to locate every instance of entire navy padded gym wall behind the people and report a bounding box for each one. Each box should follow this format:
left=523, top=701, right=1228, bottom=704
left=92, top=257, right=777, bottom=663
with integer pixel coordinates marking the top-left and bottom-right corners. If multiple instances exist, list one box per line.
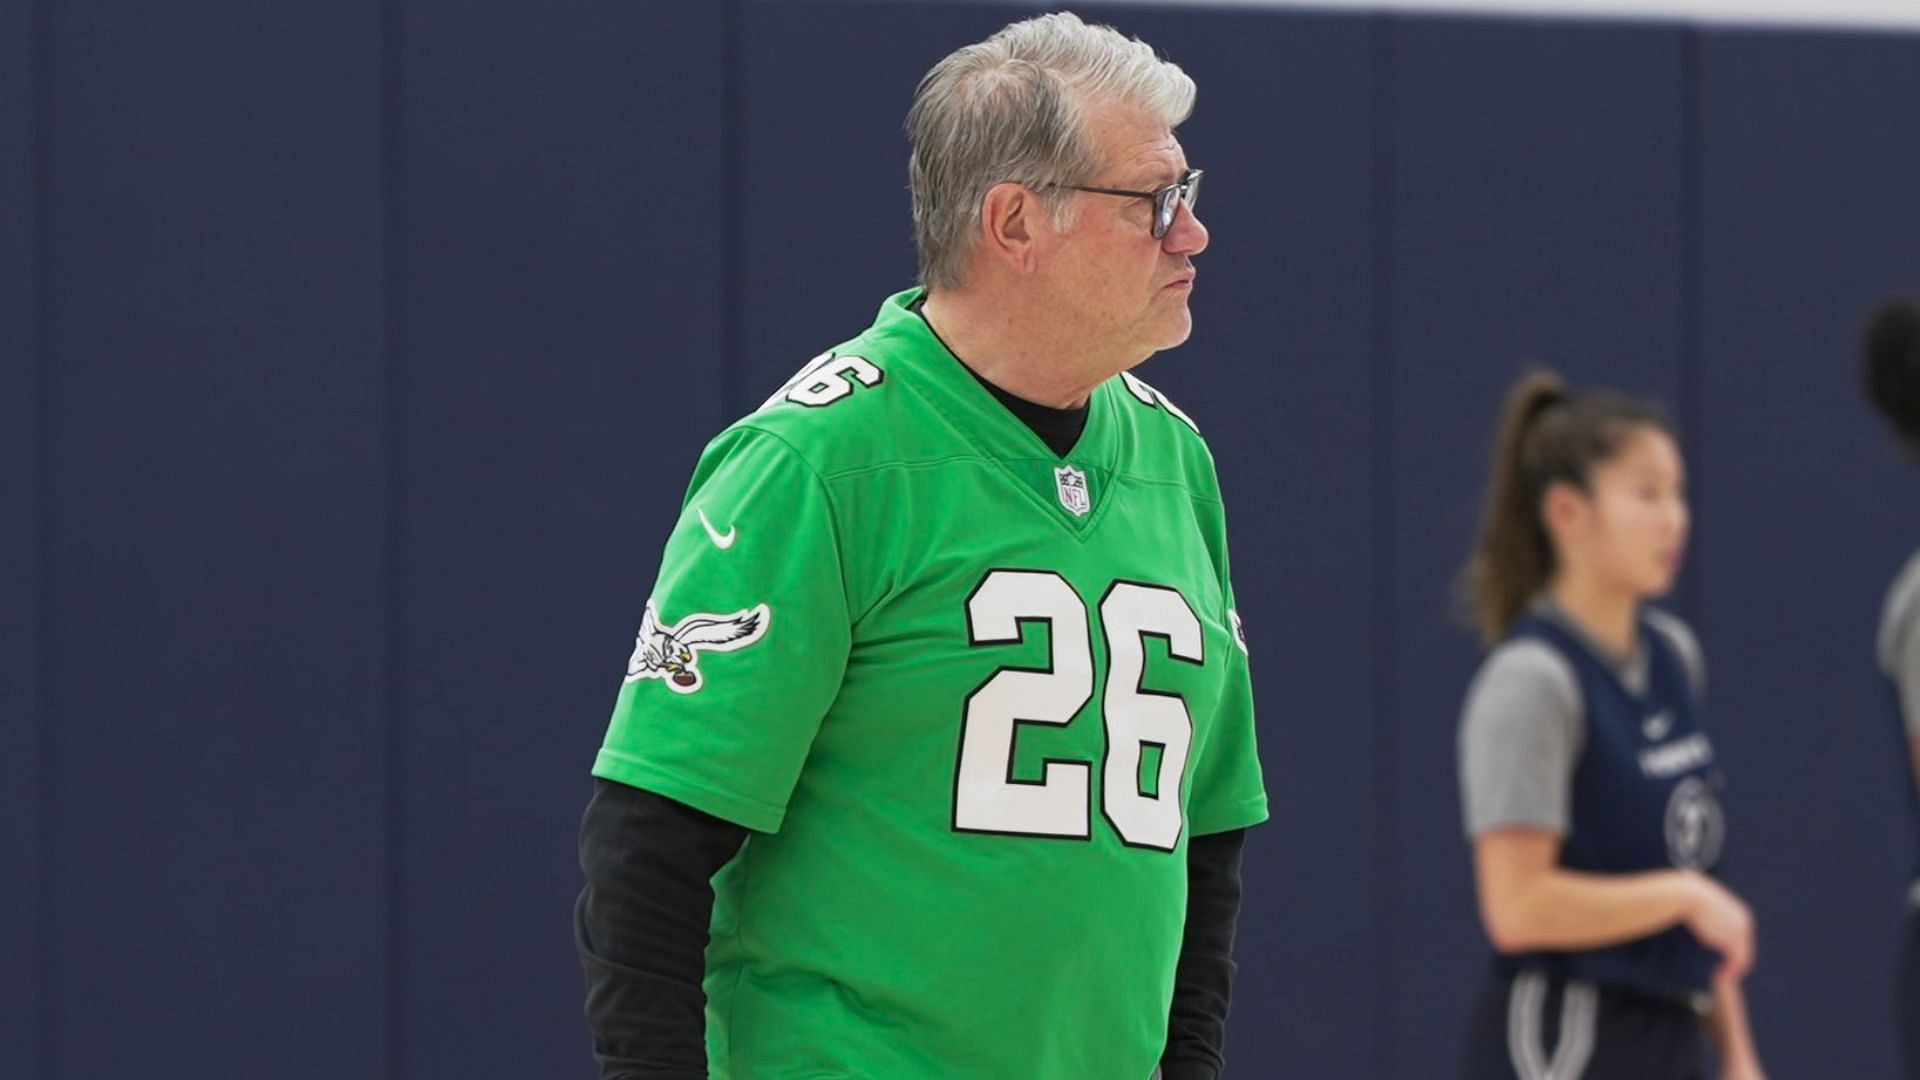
left=0, top=0, right=1920, bottom=1080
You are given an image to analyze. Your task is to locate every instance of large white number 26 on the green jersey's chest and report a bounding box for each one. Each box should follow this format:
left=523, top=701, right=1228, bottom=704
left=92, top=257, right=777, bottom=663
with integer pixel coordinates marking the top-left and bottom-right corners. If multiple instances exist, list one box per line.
left=954, top=571, right=1206, bottom=851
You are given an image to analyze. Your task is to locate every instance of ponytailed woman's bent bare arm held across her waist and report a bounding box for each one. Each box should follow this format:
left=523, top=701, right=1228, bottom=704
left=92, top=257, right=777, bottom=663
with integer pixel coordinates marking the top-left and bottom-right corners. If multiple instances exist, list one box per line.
left=1473, top=828, right=1753, bottom=974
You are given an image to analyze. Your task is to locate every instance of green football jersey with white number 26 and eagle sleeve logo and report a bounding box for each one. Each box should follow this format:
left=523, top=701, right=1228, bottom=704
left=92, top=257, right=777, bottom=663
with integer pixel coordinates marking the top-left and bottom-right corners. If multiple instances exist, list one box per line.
left=593, top=290, right=1267, bottom=1080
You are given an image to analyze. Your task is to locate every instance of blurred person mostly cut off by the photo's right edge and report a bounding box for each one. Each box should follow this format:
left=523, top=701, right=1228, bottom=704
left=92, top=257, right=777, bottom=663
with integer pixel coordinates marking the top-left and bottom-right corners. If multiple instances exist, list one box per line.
left=1862, top=300, right=1920, bottom=1078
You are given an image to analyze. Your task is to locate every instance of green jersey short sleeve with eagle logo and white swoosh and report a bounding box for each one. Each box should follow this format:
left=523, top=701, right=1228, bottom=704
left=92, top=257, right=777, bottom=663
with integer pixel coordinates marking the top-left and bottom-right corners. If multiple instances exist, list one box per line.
left=593, top=429, right=851, bottom=832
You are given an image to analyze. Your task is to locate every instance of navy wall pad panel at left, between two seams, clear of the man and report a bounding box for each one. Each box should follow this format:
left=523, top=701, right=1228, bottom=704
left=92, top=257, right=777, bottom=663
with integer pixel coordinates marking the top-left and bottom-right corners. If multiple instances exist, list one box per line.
left=33, top=0, right=388, bottom=1078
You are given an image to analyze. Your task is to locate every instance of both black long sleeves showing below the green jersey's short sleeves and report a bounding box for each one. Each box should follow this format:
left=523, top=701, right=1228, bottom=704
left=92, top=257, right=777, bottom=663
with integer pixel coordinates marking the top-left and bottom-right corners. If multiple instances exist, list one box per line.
left=574, top=780, right=1246, bottom=1080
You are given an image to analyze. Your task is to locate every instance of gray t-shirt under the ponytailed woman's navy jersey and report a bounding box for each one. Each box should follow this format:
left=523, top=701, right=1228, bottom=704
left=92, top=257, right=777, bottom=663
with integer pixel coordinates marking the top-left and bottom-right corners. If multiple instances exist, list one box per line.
left=1459, top=598, right=1712, bottom=836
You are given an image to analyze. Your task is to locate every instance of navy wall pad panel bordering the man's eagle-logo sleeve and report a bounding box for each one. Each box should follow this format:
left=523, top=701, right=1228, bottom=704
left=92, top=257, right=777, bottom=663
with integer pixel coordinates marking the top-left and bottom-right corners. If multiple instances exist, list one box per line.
left=392, top=0, right=728, bottom=1078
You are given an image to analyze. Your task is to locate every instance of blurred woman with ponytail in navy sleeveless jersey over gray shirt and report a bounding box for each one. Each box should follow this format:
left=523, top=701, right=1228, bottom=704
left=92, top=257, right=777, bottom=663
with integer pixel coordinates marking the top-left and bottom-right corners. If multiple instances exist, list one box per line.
left=1459, top=373, right=1763, bottom=1080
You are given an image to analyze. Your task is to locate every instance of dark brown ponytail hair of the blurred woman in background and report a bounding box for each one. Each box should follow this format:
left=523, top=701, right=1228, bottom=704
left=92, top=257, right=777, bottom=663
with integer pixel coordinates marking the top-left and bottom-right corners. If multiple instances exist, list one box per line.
left=1459, top=371, right=1672, bottom=646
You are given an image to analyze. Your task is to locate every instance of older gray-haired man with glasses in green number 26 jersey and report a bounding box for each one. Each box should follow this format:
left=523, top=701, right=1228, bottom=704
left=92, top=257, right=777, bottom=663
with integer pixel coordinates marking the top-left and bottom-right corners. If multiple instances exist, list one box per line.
left=576, top=13, right=1267, bottom=1080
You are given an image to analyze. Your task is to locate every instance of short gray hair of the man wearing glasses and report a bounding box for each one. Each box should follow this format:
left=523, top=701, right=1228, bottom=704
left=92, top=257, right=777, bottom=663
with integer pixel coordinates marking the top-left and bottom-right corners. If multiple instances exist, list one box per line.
left=906, top=12, right=1194, bottom=288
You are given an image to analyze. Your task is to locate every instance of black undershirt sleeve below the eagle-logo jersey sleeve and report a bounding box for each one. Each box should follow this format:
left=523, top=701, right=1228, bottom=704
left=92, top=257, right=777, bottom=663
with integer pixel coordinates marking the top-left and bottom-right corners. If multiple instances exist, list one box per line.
left=574, top=780, right=747, bottom=1080
